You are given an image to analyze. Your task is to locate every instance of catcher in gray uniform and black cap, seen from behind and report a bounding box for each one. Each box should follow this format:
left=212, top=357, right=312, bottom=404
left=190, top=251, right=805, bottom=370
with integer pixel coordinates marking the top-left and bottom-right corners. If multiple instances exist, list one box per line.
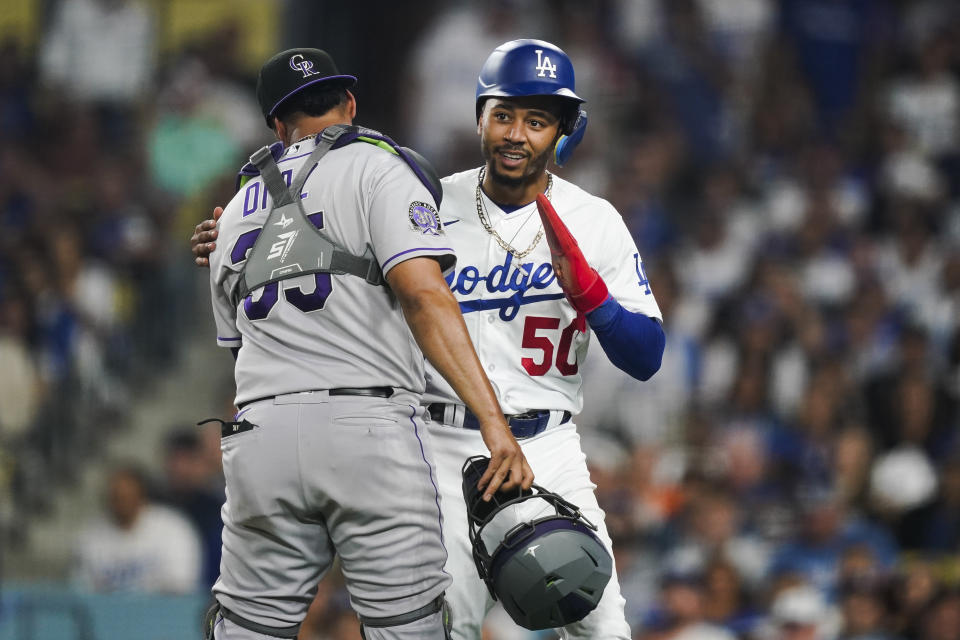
left=206, top=49, right=533, bottom=640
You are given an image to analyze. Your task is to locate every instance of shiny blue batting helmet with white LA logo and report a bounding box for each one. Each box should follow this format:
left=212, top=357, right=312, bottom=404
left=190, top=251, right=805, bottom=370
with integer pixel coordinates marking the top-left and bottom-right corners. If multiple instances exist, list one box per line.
left=477, top=39, right=587, bottom=166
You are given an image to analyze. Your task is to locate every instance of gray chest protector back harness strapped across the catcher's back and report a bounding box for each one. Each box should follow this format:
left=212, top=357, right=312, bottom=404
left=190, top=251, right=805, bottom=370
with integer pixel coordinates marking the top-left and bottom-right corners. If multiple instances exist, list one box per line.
left=233, top=125, right=384, bottom=304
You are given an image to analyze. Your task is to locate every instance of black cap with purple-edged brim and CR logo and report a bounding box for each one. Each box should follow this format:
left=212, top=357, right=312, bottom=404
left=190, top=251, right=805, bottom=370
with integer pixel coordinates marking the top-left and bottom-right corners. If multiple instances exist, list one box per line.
left=257, top=49, right=357, bottom=128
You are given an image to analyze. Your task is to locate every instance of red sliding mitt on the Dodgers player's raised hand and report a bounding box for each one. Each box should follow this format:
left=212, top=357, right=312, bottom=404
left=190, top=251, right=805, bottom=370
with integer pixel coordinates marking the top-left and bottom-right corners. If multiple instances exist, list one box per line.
left=537, top=193, right=609, bottom=315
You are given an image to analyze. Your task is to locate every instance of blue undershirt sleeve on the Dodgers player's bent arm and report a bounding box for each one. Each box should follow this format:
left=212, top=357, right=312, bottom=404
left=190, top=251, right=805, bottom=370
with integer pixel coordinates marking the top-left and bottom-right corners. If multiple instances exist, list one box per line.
left=587, top=296, right=666, bottom=380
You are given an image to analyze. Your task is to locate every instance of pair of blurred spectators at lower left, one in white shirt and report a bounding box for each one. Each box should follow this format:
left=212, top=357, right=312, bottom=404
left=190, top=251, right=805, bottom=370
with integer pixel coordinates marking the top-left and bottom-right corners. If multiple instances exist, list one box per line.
left=70, top=427, right=224, bottom=594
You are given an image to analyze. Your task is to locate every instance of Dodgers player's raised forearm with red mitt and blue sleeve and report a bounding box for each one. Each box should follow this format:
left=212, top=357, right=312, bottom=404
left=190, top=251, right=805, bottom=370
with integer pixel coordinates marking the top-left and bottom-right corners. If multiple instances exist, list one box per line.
left=537, top=194, right=666, bottom=380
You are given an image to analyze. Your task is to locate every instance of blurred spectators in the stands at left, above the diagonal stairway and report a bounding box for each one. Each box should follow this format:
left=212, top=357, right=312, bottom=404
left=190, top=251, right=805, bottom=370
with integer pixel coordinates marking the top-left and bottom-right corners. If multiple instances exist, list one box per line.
left=0, top=0, right=272, bottom=552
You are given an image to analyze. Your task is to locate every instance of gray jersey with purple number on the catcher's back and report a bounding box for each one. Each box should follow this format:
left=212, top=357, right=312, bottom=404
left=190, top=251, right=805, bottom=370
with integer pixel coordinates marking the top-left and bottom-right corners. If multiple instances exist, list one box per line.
left=210, top=139, right=455, bottom=403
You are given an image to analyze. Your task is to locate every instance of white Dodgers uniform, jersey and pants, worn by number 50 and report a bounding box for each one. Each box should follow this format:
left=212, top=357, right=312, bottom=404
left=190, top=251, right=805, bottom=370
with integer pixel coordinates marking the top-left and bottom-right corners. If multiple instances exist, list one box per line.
left=432, top=169, right=660, bottom=640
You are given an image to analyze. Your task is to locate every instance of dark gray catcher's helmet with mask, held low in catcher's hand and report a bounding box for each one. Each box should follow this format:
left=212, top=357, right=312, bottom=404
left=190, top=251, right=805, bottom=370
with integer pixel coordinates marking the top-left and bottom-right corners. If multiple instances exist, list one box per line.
left=462, top=456, right=613, bottom=630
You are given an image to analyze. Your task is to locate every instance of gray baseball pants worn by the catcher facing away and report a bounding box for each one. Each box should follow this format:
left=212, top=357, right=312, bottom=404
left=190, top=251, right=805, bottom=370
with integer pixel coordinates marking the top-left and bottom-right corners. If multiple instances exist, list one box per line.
left=213, top=390, right=451, bottom=640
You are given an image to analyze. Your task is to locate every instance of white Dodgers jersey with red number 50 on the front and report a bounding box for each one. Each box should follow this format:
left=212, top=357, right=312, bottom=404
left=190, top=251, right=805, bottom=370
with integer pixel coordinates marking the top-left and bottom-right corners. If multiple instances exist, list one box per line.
left=424, top=169, right=661, bottom=414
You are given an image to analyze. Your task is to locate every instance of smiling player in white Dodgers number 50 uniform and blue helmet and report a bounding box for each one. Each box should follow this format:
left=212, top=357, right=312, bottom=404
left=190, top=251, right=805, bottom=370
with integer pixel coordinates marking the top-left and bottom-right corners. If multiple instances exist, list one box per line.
left=191, top=40, right=664, bottom=640
